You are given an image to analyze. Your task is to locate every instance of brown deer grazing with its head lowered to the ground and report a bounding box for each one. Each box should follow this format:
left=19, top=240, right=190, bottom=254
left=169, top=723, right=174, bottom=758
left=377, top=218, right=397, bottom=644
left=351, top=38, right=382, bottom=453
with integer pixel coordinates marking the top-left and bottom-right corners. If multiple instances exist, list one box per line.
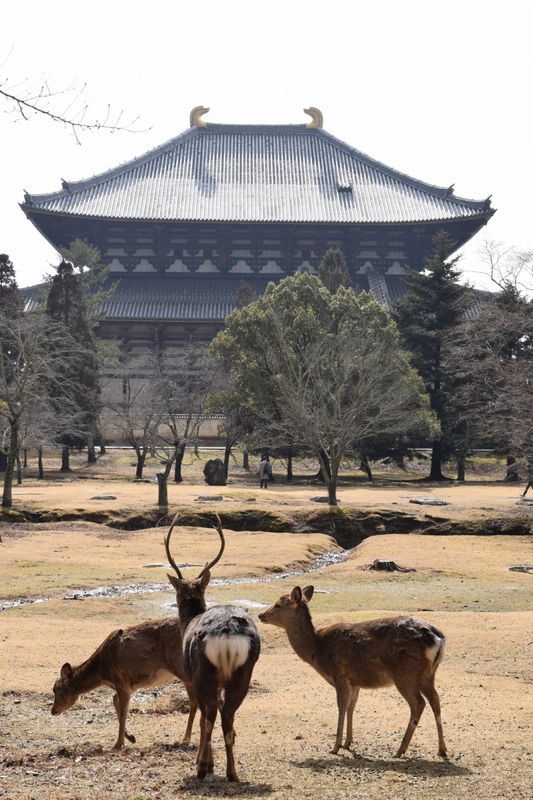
left=52, top=618, right=197, bottom=750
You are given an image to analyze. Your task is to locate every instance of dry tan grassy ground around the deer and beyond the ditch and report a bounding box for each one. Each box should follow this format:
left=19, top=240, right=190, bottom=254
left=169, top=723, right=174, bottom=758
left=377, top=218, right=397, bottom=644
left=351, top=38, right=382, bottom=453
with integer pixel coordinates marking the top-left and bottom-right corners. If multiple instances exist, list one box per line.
left=0, top=466, right=533, bottom=800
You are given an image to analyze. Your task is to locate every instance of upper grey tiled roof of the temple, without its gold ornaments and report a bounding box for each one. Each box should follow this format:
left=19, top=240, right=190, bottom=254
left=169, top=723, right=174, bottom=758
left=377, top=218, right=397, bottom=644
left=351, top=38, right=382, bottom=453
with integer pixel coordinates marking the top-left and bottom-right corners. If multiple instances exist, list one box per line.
left=23, top=124, right=493, bottom=224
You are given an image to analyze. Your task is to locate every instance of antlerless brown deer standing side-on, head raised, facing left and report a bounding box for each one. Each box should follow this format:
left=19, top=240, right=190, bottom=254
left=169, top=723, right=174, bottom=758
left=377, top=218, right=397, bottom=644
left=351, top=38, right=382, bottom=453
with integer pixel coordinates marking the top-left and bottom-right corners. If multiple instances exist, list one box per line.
left=259, top=586, right=446, bottom=758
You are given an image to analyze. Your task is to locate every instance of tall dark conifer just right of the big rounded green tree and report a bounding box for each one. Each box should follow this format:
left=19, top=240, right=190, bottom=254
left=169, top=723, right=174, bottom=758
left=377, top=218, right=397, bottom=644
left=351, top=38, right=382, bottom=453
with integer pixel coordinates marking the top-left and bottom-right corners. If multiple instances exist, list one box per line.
left=396, top=231, right=467, bottom=481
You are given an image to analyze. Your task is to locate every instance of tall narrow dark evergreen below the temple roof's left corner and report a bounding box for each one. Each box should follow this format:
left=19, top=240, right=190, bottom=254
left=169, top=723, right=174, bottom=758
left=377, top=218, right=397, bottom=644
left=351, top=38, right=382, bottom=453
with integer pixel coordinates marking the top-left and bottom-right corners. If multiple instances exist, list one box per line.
left=46, top=261, right=100, bottom=471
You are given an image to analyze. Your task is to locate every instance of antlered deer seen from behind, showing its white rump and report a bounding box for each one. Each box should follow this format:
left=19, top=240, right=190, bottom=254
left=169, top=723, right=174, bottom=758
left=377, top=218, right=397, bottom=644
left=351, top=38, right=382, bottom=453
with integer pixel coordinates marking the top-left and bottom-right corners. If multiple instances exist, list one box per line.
left=164, top=515, right=260, bottom=781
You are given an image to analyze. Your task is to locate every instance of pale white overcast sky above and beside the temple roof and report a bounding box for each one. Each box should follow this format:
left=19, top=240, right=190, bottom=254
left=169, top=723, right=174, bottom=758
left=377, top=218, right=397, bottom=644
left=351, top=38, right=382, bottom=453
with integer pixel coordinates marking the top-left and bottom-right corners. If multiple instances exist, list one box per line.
left=0, top=0, right=533, bottom=286
